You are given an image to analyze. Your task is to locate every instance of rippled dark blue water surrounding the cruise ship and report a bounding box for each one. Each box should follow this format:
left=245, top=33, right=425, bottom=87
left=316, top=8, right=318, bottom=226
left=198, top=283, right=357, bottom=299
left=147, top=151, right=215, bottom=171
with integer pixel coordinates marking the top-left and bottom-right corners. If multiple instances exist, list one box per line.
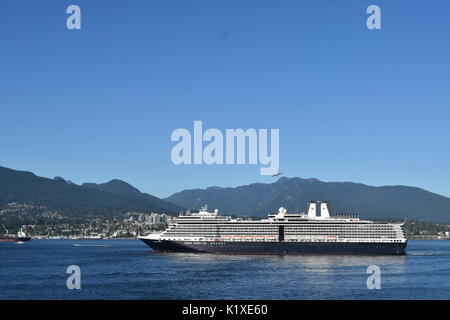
left=0, top=240, right=450, bottom=299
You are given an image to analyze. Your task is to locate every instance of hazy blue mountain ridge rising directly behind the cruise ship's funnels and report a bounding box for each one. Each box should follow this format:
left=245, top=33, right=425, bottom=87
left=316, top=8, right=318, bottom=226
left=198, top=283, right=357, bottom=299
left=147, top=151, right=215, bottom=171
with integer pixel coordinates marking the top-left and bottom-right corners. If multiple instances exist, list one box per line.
left=164, top=177, right=450, bottom=223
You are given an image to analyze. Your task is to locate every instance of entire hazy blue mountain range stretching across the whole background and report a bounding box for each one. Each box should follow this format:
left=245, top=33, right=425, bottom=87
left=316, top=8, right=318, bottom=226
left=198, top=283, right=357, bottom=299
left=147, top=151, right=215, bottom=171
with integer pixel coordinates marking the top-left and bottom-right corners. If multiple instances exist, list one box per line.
left=0, top=167, right=450, bottom=223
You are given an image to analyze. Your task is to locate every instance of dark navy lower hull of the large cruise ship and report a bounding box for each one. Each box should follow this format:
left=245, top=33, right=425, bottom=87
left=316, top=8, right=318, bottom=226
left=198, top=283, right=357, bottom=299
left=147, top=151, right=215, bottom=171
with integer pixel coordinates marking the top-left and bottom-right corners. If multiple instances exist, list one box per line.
left=140, top=238, right=407, bottom=255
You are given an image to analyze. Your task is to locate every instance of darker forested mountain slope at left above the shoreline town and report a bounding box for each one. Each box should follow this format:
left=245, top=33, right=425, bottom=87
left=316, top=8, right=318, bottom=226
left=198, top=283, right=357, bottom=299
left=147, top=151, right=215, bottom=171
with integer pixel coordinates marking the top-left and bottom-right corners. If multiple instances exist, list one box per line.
left=0, top=167, right=182, bottom=215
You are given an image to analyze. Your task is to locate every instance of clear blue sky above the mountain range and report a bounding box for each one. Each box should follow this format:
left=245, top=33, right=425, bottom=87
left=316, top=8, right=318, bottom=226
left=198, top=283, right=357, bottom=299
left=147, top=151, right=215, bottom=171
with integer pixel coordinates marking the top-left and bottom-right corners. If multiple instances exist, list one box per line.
left=0, top=0, right=450, bottom=197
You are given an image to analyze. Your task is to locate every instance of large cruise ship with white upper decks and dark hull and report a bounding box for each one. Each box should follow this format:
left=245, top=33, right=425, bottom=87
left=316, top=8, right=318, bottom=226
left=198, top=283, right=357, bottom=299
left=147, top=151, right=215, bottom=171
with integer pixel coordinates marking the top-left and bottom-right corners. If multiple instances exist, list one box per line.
left=139, top=201, right=407, bottom=255
